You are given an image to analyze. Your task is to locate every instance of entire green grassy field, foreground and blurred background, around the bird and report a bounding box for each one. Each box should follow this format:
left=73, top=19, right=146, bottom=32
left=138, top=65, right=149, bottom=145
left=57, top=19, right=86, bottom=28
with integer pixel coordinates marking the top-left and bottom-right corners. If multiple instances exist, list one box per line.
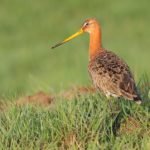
left=0, top=0, right=150, bottom=150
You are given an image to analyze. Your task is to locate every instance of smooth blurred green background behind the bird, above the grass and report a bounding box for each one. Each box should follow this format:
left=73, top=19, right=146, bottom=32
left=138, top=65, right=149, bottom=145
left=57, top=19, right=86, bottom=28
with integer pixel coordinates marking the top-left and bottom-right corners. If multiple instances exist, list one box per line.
left=0, top=0, right=150, bottom=96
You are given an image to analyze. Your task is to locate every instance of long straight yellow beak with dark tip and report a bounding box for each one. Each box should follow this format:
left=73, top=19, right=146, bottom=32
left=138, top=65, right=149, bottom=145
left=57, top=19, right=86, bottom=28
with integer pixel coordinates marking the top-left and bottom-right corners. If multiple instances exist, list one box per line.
left=51, top=28, right=84, bottom=49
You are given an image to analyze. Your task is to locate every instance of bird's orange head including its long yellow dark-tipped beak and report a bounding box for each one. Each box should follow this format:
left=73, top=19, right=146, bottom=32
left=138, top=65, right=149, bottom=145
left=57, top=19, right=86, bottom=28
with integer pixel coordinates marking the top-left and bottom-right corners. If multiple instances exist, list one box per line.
left=51, top=18, right=99, bottom=49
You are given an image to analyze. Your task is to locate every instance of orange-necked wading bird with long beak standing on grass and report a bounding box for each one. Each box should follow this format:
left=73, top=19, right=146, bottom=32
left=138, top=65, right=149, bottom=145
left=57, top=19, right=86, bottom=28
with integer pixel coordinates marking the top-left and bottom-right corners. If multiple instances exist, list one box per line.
left=51, top=18, right=142, bottom=104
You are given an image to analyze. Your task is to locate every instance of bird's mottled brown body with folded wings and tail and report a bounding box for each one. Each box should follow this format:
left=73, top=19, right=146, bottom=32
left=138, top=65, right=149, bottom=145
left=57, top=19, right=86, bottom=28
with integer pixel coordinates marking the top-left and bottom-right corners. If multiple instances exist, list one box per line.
left=89, top=49, right=141, bottom=103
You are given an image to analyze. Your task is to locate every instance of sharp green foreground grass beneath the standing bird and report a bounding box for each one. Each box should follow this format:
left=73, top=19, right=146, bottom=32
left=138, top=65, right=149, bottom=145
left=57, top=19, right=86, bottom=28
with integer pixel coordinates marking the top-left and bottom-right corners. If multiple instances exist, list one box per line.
left=0, top=89, right=150, bottom=150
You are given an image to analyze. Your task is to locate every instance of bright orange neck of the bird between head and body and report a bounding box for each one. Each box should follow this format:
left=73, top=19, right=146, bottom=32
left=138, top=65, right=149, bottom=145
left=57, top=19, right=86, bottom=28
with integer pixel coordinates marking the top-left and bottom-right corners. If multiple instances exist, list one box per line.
left=89, top=27, right=102, bottom=60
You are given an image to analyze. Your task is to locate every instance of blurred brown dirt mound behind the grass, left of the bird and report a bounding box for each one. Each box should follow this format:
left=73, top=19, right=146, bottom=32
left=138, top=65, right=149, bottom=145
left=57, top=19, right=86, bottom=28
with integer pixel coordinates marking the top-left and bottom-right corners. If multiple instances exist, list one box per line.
left=16, top=87, right=96, bottom=106
